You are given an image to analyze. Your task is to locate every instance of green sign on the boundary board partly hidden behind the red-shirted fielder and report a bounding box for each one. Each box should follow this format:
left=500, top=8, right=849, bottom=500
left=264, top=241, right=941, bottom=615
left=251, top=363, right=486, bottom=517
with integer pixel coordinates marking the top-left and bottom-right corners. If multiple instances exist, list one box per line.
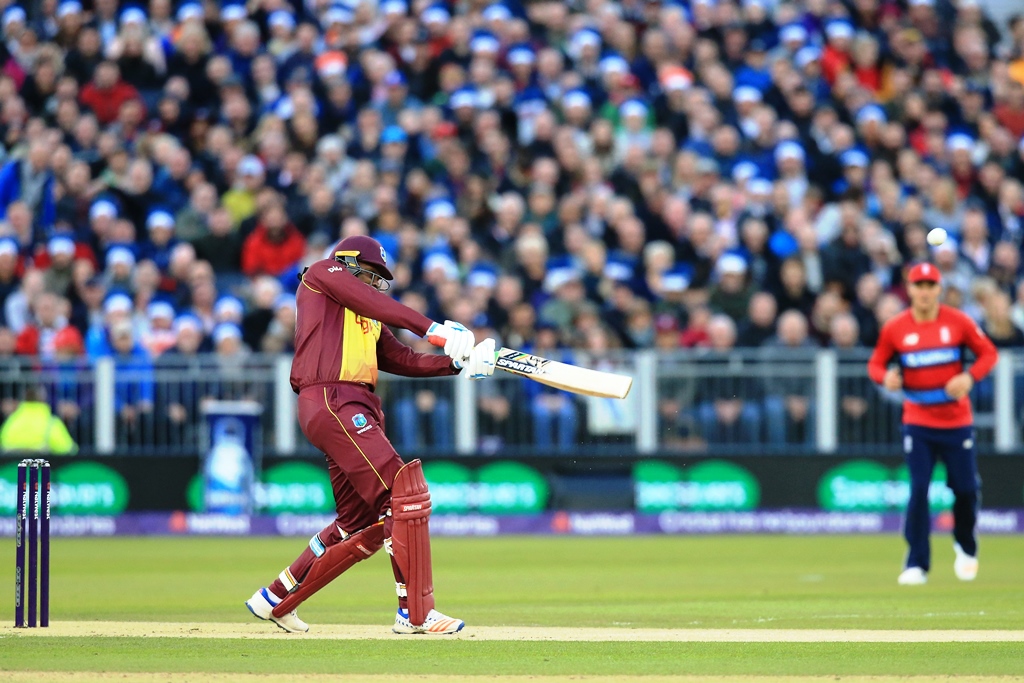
left=818, top=460, right=953, bottom=512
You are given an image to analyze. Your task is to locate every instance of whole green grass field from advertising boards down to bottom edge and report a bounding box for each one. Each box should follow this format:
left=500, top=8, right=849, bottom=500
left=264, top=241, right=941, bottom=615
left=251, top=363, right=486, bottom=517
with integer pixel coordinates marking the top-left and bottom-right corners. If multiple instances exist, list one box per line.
left=0, top=536, right=1024, bottom=682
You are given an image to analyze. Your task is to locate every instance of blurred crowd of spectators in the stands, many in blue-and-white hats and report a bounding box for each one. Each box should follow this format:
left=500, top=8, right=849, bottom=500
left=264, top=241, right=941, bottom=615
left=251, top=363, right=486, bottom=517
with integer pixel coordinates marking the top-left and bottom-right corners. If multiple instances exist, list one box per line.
left=0, top=0, right=1024, bottom=445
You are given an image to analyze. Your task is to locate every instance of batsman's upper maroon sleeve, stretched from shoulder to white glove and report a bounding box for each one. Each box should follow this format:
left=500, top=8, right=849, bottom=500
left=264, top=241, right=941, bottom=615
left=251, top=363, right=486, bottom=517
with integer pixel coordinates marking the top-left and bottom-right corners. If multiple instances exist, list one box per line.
left=302, top=260, right=431, bottom=341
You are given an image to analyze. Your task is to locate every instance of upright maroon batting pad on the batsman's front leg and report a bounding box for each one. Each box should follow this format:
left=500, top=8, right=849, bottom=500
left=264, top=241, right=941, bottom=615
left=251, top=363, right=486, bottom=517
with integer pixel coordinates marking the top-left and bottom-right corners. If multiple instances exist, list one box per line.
left=391, top=460, right=434, bottom=626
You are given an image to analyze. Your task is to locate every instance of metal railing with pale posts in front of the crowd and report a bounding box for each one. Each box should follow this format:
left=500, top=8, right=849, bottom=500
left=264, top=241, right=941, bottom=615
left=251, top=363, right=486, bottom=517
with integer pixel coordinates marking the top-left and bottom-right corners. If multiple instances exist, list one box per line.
left=0, top=348, right=1024, bottom=456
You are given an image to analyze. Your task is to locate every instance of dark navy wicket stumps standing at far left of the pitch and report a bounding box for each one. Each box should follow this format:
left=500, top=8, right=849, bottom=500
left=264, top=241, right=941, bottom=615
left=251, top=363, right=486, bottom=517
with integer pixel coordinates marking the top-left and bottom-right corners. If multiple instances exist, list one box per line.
left=14, top=460, right=50, bottom=628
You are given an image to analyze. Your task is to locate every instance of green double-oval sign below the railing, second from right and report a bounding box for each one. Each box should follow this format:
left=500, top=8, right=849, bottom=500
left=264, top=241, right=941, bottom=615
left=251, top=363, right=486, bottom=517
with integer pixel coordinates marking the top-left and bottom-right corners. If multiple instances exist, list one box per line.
left=633, top=460, right=761, bottom=513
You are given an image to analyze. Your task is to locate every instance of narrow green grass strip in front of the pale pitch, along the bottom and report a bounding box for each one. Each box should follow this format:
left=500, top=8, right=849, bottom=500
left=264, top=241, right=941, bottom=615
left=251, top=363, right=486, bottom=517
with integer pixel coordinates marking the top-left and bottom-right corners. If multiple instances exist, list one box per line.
left=0, top=638, right=1022, bottom=677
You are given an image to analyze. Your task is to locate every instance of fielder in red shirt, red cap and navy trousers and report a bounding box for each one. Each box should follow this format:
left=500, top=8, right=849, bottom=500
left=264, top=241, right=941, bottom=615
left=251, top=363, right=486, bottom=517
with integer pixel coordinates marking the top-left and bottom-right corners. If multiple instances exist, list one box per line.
left=867, top=263, right=997, bottom=586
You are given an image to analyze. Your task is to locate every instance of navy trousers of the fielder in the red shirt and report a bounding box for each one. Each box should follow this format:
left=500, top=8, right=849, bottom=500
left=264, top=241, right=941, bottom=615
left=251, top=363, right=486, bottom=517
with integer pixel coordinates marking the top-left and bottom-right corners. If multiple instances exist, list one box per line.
left=903, top=425, right=981, bottom=571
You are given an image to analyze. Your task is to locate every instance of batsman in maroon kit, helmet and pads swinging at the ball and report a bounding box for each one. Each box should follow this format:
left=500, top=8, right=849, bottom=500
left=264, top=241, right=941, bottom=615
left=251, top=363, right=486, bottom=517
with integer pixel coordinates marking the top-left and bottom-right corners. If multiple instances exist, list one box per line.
left=246, top=236, right=495, bottom=634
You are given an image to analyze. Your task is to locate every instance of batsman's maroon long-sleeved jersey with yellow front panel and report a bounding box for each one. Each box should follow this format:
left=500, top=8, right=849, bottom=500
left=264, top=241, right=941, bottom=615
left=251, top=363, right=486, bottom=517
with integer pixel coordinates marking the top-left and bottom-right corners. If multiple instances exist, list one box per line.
left=291, top=259, right=458, bottom=393
